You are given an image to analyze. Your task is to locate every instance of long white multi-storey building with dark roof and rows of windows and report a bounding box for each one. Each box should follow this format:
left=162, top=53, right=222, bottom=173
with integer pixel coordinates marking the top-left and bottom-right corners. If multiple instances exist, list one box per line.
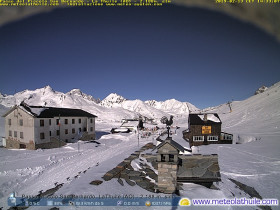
left=2, top=103, right=96, bottom=149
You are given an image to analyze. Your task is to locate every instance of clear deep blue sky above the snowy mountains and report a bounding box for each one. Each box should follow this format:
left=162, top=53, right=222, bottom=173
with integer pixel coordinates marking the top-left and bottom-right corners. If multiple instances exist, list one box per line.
left=0, top=5, right=280, bottom=108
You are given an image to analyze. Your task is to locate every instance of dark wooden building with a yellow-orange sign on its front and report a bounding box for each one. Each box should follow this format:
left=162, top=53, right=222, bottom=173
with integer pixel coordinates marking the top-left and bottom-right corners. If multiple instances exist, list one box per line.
left=184, top=113, right=233, bottom=147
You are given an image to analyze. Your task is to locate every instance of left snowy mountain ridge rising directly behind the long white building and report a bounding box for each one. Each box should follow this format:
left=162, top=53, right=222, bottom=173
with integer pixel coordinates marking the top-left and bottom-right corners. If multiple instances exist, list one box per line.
left=0, top=86, right=137, bottom=121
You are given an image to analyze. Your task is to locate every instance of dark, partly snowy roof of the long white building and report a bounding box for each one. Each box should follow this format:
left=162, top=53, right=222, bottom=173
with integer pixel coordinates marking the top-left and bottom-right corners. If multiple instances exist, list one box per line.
left=20, top=104, right=97, bottom=118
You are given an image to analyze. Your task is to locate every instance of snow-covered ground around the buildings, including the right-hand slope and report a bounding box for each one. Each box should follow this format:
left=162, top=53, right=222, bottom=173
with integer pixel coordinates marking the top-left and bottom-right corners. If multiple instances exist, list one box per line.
left=0, top=83, right=280, bottom=209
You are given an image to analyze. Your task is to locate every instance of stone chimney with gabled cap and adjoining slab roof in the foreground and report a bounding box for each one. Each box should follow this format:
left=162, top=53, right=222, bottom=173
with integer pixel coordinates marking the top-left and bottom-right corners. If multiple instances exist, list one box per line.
left=156, top=138, right=221, bottom=194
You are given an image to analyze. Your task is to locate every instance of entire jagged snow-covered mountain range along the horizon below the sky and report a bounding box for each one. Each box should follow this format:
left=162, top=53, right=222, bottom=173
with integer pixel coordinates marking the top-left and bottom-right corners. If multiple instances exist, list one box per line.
left=0, top=86, right=198, bottom=121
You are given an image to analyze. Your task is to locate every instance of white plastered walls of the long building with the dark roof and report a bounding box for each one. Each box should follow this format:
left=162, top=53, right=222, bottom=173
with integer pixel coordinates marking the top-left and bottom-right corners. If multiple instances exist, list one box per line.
left=5, top=107, right=95, bottom=144
